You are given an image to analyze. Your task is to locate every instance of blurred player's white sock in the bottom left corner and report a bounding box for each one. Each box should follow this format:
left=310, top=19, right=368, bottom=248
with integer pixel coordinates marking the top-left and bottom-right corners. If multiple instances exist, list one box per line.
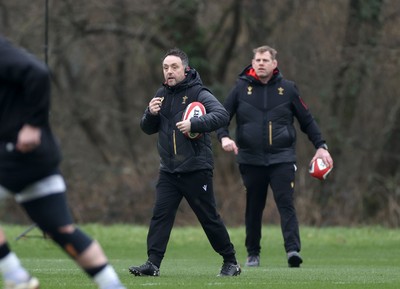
left=0, top=252, right=30, bottom=283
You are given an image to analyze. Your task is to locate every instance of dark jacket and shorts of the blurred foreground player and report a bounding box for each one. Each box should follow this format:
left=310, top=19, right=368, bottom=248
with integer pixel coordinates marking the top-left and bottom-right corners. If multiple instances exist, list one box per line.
left=0, top=36, right=61, bottom=190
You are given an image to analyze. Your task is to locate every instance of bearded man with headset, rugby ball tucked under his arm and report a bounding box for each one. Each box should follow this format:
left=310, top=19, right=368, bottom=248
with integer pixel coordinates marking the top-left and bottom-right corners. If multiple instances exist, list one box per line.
left=129, top=48, right=241, bottom=276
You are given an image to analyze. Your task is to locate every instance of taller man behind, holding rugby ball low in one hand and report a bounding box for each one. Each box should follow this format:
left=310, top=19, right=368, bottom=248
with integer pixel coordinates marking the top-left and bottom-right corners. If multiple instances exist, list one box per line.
left=217, top=46, right=333, bottom=267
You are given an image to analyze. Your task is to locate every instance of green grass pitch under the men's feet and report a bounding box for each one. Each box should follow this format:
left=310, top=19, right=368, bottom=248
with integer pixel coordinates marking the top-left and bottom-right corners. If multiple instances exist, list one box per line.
left=3, top=224, right=400, bottom=289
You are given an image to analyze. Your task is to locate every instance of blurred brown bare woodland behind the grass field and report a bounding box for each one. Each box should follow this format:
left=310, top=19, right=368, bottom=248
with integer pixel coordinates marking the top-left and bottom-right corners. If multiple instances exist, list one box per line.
left=0, top=0, right=400, bottom=226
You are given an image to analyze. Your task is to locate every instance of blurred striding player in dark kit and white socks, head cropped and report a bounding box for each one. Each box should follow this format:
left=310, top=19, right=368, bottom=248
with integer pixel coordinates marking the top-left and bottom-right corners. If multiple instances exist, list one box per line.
left=0, top=36, right=125, bottom=289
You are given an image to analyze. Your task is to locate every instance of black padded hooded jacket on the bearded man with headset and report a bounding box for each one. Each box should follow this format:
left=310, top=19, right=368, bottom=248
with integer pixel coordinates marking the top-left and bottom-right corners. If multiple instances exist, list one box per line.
left=140, top=69, right=229, bottom=173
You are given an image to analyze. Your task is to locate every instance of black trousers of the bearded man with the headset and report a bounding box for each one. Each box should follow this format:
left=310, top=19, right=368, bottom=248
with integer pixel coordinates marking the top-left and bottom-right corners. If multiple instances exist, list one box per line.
left=147, top=170, right=236, bottom=267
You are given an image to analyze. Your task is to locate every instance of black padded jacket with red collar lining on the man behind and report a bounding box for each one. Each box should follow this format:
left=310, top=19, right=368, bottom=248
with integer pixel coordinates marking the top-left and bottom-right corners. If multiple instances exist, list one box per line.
left=217, top=65, right=325, bottom=166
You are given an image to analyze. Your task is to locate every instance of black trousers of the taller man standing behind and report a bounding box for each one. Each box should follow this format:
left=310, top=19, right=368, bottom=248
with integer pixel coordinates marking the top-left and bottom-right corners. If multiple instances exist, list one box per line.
left=239, top=163, right=301, bottom=256
